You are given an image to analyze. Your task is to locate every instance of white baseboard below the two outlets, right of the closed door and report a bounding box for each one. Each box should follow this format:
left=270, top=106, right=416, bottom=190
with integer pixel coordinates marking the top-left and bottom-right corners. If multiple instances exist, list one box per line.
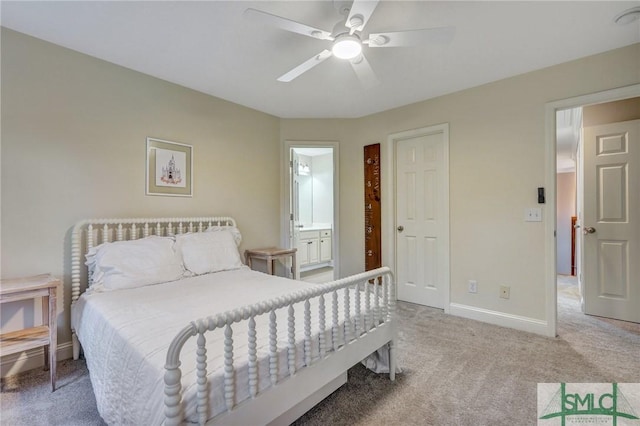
left=449, top=303, right=555, bottom=337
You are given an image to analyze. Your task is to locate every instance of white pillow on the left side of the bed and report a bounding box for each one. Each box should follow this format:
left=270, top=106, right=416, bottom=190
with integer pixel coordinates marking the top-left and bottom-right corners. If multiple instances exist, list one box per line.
left=86, top=236, right=184, bottom=291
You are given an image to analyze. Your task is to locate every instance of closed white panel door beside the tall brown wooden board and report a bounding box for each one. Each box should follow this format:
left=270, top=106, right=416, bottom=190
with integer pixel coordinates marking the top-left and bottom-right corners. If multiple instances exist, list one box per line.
left=395, top=125, right=449, bottom=308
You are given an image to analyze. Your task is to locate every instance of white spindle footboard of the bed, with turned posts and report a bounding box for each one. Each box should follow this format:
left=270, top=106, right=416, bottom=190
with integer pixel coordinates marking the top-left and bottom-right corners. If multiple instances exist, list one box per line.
left=164, top=267, right=396, bottom=425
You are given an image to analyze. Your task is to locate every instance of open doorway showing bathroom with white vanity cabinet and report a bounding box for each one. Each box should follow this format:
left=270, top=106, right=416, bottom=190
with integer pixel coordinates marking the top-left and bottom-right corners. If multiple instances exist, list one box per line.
left=284, top=142, right=338, bottom=283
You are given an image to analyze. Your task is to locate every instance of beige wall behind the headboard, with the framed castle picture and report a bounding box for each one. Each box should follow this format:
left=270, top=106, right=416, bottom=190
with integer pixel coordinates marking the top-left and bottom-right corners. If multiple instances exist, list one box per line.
left=1, top=28, right=280, bottom=356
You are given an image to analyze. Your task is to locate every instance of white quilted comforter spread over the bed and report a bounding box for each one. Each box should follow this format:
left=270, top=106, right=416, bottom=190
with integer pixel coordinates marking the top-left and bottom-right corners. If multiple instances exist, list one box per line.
left=72, top=267, right=332, bottom=425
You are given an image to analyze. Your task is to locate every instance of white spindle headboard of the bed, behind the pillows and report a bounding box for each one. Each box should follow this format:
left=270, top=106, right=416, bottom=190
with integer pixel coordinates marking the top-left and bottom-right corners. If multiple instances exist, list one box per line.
left=71, top=216, right=236, bottom=304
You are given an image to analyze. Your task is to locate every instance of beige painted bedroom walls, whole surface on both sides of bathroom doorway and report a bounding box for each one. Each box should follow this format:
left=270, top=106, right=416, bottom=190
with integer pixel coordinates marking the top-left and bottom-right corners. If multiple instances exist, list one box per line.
left=1, top=25, right=640, bottom=372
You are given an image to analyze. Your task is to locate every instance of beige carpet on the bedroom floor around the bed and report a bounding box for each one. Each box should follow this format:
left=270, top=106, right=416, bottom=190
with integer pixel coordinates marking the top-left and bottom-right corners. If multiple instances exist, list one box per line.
left=0, top=280, right=640, bottom=426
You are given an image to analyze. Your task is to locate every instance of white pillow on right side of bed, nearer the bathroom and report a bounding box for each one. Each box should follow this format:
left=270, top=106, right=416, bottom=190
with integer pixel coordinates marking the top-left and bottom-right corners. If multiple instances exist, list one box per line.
left=176, top=229, right=243, bottom=275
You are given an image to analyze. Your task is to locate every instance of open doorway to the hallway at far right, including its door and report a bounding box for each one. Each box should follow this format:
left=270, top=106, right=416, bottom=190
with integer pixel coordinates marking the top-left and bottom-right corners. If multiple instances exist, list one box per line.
left=546, top=85, right=640, bottom=335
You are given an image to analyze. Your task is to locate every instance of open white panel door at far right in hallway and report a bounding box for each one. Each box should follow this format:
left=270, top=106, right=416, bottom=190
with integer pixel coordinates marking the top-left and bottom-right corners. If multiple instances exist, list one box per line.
left=581, top=120, right=640, bottom=322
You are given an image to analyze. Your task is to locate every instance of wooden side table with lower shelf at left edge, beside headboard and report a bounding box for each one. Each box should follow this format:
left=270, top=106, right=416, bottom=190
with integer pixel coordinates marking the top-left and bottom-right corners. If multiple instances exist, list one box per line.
left=0, top=274, right=60, bottom=392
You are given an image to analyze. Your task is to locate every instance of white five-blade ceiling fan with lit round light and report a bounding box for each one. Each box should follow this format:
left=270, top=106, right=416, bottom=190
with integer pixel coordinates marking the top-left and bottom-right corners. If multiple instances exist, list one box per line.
left=244, top=0, right=455, bottom=88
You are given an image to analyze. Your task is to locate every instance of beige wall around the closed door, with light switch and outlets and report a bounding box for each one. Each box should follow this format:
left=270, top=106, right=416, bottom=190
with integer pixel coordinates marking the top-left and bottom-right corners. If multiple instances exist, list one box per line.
left=281, top=44, right=640, bottom=320
